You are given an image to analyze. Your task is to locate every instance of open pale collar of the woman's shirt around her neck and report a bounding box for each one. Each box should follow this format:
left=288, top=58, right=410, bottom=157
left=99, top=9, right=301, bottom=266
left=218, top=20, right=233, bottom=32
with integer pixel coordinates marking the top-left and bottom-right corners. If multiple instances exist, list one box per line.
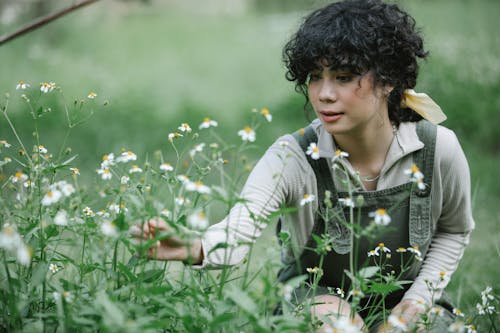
left=311, top=119, right=424, bottom=172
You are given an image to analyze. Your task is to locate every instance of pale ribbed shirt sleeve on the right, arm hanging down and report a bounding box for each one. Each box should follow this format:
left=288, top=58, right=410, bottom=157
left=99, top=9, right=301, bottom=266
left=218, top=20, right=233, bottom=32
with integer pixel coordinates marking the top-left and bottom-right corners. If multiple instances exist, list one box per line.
left=404, top=127, right=474, bottom=304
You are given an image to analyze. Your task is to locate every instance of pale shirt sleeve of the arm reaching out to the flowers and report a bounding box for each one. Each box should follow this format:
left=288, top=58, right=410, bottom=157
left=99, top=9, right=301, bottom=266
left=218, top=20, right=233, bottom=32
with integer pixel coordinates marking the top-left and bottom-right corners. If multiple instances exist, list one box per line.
left=197, top=135, right=303, bottom=268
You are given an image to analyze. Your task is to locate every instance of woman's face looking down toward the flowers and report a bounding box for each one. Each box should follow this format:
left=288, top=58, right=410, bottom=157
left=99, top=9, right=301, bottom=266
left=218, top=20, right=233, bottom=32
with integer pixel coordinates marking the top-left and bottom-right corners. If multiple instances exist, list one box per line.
left=308, top=66, right=390, bottom=135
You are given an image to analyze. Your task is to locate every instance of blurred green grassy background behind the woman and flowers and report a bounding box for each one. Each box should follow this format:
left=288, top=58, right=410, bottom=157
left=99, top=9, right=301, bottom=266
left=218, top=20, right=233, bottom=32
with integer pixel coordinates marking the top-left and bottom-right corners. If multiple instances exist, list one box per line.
left=0, top=0, right=500, bottom=310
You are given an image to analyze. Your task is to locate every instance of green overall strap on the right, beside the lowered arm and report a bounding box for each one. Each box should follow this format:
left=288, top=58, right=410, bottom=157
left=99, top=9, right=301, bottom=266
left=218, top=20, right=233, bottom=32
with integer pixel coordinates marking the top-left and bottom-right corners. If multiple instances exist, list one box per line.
left=410, top=120, right=437, bottom=247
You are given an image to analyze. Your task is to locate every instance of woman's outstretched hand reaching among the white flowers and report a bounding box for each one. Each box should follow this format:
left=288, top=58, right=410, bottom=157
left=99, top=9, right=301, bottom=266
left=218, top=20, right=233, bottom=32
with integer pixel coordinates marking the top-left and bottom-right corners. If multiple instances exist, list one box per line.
left=130, top=218, right=203, bottom=264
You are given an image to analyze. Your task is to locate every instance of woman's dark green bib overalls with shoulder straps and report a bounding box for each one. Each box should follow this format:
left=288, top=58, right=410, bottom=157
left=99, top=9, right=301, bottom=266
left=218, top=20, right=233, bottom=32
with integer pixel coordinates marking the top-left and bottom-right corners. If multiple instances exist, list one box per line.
left=278, top=120, right=456, bottom=330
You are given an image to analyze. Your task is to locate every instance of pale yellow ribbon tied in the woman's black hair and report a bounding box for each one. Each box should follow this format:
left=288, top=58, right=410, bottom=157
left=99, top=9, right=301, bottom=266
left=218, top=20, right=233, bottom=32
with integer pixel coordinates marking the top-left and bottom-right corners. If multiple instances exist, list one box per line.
left=401, top=89, right=446, bottom=124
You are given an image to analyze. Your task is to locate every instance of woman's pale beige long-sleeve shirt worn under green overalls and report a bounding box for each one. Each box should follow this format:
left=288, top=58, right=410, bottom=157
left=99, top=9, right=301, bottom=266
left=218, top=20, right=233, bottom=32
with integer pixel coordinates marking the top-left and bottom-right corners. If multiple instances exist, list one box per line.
left=198, top=119, right=474, bottom=303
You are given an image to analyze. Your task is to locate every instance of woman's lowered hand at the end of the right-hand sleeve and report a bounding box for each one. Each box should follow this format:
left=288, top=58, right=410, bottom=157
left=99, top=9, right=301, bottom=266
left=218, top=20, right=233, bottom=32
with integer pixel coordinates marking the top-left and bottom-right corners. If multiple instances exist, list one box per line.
left=377, top=300, right=425, bottom=333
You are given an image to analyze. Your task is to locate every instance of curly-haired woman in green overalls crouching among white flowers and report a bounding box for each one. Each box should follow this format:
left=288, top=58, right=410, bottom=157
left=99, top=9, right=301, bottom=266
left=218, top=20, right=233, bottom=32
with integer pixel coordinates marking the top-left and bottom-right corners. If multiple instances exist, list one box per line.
left=136, top=0, right=474, bottom=332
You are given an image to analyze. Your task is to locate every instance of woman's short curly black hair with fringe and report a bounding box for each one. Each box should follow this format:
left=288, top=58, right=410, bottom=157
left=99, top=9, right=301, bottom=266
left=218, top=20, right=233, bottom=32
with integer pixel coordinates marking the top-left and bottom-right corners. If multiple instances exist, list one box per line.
left=283, top=0, right=428, bottom=124
